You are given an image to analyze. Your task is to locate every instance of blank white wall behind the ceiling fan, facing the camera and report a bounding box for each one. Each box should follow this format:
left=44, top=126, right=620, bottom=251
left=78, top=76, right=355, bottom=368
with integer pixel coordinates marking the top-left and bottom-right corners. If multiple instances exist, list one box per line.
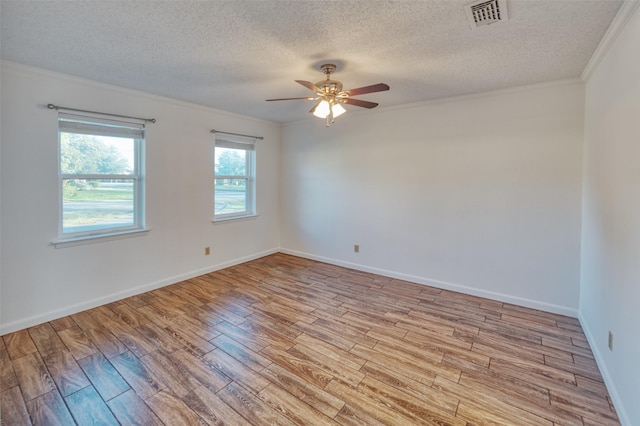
left=281, top=82, right=584, bottom=316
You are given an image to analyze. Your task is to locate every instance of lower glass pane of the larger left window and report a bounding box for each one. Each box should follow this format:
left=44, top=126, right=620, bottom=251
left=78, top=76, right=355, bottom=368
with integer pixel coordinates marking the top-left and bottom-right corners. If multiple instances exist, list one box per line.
left=62, top=179, right=135, bottom=233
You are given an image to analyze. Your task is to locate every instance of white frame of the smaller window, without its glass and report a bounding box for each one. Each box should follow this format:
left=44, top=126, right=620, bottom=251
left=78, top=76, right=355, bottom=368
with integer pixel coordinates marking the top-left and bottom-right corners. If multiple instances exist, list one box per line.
left=213, top=134, right=256, bottom=222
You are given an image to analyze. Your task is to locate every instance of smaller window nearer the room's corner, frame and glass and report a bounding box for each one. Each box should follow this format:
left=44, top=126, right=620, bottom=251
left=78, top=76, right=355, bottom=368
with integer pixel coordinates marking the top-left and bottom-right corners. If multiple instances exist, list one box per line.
left=213, top=136, right=255, bottom=220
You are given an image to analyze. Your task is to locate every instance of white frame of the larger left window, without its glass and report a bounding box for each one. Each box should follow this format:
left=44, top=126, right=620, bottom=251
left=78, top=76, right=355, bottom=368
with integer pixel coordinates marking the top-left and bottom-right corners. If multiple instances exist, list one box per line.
left=54, top=112, right=146, bottom=244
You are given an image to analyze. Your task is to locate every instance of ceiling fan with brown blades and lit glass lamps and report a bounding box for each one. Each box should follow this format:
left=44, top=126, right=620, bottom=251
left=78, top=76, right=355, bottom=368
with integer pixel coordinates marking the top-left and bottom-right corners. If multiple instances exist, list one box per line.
left=267, top=64, right=389, bottom=127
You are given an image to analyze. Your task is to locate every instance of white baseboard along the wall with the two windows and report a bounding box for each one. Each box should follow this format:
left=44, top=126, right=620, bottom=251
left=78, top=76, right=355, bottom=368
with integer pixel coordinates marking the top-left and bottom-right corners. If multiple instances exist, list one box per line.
left=0, top=248, right=279, bottom=336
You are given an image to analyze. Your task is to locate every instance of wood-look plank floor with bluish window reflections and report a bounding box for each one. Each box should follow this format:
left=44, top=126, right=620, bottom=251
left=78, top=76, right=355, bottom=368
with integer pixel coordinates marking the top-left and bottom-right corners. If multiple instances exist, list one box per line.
left=0, top=254, right=619, bottom=426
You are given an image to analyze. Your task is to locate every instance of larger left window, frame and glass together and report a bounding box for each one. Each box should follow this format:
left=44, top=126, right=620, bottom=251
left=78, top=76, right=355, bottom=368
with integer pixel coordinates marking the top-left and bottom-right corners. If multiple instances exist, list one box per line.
left=58, top=113, right=144, bottom=240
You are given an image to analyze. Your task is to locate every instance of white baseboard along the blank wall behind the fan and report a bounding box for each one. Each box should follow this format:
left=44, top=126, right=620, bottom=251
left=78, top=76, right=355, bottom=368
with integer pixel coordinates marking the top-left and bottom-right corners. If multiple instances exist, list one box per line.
left=280, top=248, right=578, bottom=318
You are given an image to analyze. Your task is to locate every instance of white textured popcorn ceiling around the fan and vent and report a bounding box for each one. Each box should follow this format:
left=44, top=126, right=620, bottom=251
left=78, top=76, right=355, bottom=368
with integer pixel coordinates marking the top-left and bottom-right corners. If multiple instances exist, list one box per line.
left=0, top=0, right=621, bottom=122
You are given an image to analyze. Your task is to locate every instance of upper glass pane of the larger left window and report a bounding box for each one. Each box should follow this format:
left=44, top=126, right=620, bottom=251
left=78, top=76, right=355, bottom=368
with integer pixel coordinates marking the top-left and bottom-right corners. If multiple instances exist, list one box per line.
left=60, top=132, right=135, bottom=174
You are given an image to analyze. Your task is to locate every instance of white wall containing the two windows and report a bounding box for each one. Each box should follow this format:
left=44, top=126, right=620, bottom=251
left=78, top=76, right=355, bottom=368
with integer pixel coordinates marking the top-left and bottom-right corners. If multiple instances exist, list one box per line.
left=0, top=63, right=281, bottom=334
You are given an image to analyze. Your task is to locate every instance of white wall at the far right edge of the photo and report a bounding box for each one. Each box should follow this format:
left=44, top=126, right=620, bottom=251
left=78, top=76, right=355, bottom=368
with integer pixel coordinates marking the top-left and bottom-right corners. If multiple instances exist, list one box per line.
left=580, top=5, right=640, bottom=425
